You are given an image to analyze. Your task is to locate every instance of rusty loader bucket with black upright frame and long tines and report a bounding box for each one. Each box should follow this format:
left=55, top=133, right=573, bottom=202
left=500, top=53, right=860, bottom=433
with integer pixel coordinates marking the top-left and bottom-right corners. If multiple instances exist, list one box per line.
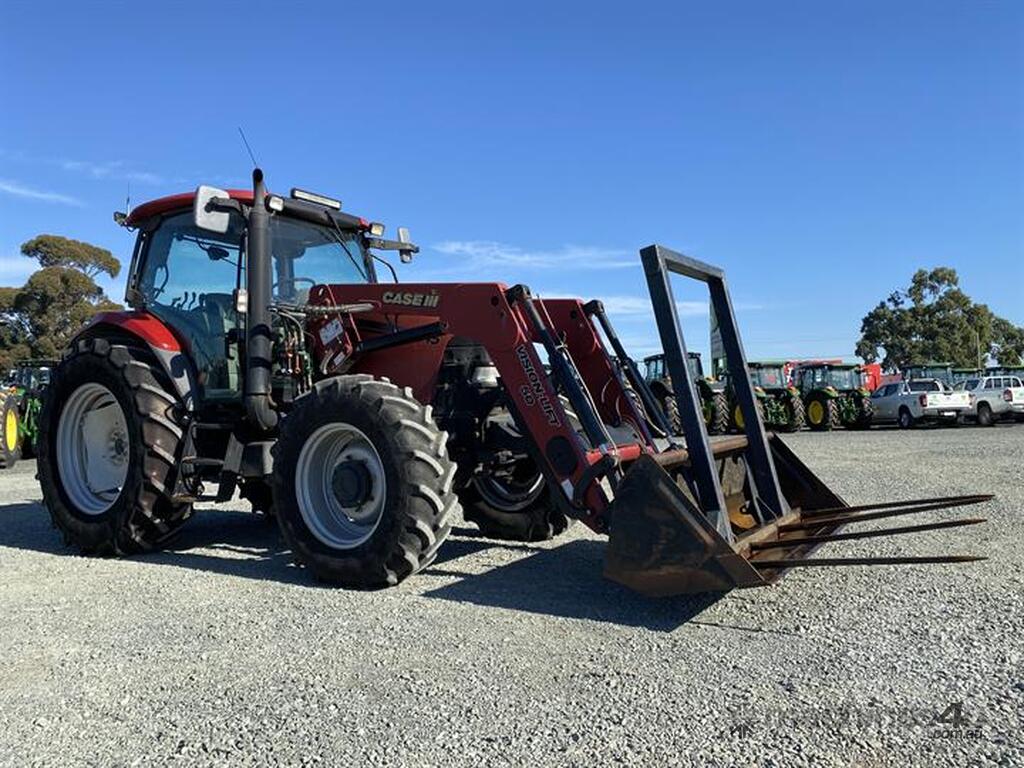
left=598, top=246, right=992, bottom=596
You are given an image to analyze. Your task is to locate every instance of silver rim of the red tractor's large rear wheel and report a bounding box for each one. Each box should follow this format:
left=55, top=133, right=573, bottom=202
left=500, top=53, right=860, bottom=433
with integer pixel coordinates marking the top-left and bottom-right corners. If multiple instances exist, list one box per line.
left=56, top=384, right=130, bottom=516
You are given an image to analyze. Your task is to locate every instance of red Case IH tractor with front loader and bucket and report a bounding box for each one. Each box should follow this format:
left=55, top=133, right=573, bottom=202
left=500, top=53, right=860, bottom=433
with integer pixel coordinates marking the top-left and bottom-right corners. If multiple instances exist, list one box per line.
left=39, top=170, right=981, bottom=594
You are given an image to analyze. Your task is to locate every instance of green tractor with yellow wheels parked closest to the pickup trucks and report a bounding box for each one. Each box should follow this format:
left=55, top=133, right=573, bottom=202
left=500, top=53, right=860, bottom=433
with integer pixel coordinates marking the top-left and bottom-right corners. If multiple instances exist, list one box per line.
left=793, top=362, right=872, bottom=431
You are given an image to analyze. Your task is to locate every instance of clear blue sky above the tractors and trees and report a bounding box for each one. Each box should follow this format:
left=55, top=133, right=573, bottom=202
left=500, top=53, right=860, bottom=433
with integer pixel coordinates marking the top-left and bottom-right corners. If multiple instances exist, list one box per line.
left=0, top=1, right=1024, bottom=358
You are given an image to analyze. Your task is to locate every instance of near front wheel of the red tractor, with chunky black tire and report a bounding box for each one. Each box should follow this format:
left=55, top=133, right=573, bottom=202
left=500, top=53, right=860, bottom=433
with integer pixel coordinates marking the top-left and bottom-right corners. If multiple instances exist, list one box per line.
left=273, top=375, right=459, bottom=589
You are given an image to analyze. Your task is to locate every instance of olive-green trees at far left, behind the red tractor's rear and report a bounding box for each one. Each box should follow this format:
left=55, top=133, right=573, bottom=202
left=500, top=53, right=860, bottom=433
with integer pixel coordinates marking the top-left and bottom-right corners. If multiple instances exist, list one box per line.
left=0, top=234, right=121, bottom=370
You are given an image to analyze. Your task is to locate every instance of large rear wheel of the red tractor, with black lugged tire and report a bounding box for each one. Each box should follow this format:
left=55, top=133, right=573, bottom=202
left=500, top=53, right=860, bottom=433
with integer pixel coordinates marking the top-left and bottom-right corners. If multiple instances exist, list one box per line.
left=38, top=338, right=191, bottom=555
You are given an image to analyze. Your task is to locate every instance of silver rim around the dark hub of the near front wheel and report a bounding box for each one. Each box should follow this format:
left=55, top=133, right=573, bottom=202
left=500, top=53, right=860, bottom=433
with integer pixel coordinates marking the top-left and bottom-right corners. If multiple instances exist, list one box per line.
left=295, top=423, right=387, bottom=550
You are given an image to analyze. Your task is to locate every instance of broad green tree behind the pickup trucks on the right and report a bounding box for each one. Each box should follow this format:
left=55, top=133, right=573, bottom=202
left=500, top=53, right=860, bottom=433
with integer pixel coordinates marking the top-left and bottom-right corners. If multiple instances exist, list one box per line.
left=856, top=266, right=1024, bottom=369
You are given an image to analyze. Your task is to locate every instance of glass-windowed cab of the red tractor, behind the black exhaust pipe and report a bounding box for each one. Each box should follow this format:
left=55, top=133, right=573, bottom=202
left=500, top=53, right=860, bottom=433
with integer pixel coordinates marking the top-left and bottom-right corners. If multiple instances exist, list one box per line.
left=126, top=193, right=397, bottom=406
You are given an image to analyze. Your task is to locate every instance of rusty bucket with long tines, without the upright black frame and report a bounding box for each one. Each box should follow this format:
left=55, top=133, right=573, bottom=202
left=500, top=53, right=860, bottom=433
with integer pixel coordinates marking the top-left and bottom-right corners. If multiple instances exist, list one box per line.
left=604, top=435, right=992, bottom=597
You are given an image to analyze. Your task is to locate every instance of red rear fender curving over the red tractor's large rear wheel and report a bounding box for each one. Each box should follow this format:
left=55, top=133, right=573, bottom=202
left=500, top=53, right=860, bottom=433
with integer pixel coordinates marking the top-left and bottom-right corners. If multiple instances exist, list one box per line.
left=72, top=310, right=197, bottom=411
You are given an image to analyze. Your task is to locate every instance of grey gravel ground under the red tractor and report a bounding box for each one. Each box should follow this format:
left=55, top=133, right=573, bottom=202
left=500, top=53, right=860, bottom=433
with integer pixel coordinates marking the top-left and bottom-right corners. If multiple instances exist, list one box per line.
left=0, top=425, right=1024, bottom=766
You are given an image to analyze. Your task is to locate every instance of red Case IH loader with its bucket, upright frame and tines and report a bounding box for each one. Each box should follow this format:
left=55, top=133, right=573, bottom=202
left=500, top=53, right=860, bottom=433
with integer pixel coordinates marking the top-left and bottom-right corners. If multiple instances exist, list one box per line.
left=308, top=246, right=991, bottom=595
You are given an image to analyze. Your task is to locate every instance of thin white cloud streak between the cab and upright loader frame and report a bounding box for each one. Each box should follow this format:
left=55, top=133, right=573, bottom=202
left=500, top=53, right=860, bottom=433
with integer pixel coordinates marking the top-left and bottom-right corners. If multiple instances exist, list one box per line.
left=432, top=240, right=638, bottom=269
